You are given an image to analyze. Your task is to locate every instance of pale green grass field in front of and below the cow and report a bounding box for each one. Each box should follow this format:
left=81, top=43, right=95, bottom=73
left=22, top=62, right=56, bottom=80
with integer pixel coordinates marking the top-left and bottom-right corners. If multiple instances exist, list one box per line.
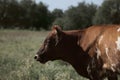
left=0, top=30, right=87, bottom=80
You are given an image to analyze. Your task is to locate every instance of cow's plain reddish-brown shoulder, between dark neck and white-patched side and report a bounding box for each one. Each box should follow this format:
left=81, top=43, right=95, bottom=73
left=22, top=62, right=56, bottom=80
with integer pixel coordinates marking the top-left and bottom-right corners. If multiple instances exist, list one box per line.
left=79, top=26, right=104, bottom=51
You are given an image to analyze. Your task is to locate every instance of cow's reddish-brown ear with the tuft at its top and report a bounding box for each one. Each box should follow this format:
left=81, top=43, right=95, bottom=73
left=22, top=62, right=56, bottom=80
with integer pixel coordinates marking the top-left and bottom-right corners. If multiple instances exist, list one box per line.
left=52, top=25, right=62, bottom=46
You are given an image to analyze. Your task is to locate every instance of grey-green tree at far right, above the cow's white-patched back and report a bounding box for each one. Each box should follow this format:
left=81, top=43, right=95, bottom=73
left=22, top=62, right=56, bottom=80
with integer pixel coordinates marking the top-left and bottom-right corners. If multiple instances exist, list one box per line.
left=93, top=0, right=120, bottom=24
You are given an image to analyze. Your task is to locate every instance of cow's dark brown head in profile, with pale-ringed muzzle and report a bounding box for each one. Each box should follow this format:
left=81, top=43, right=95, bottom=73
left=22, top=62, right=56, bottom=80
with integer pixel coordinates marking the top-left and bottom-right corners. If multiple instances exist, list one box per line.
left=34, top=25, right=63, bottom=63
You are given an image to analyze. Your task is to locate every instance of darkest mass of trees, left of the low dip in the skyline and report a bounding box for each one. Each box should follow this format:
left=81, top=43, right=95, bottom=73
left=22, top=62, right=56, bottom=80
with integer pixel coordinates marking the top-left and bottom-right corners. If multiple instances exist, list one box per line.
left=0, top=0, right=51, bottom=30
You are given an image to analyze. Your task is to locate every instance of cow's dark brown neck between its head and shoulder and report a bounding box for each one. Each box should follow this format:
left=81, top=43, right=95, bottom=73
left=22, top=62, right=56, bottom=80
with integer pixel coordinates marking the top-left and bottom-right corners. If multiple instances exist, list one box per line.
left=60, top=31, right=90, bottom=77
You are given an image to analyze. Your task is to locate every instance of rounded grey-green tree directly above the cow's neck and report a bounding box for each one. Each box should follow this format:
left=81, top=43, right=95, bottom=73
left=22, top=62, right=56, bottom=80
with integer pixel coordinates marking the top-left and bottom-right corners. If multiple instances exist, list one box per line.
left=54, top=2, right=97, bottom=29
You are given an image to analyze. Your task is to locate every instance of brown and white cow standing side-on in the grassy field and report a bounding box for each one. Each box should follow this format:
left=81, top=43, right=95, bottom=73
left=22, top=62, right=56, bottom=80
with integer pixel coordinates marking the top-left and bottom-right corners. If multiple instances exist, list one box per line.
left=35, top=25, right=120, bottom=80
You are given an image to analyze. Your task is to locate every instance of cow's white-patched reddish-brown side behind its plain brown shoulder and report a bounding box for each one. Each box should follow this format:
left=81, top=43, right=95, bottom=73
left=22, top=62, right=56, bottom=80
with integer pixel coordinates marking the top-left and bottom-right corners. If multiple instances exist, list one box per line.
left=95, top=25, right=120, bottom=72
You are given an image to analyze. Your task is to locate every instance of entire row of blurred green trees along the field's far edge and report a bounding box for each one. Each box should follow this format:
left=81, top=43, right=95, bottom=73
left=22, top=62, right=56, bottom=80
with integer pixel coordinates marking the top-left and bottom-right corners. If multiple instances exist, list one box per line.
left=0, top=0, right=120, bottom=30
